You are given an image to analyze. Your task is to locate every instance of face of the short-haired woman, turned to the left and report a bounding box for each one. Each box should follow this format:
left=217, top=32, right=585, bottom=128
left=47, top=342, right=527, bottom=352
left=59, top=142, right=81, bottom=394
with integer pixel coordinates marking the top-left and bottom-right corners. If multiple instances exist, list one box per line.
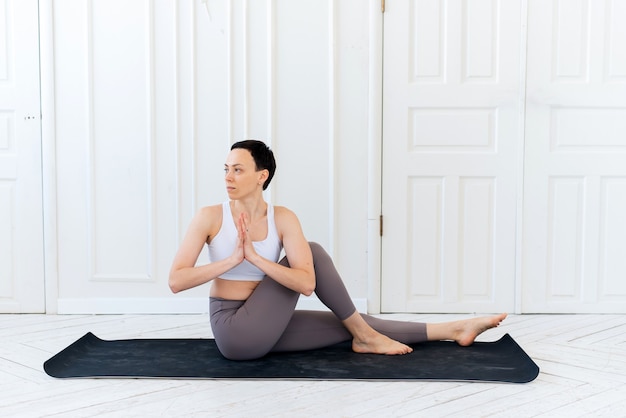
left=224, top=148, right=267, bottom=199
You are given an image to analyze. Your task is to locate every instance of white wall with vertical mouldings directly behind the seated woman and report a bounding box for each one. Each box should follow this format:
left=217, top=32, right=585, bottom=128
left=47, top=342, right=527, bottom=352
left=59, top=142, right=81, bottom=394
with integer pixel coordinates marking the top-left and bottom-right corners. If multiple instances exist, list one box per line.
left=42, top=0, right=372, bottom=312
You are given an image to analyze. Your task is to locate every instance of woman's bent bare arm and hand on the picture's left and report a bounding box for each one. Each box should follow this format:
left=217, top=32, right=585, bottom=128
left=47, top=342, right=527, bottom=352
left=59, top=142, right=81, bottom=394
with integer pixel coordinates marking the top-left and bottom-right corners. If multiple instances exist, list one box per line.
left=169, top=205, right=243, bottom=293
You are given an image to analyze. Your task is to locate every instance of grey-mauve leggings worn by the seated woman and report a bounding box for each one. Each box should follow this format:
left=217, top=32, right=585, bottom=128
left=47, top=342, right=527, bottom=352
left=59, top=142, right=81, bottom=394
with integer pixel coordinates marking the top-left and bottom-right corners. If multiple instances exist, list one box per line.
left=210, top=242, right=427, bottom=360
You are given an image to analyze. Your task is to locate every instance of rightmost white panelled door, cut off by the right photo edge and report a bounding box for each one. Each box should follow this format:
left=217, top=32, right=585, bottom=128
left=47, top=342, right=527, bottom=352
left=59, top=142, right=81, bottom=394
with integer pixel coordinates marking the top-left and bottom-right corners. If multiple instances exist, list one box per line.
left=522, top=0, right=626, bottom=313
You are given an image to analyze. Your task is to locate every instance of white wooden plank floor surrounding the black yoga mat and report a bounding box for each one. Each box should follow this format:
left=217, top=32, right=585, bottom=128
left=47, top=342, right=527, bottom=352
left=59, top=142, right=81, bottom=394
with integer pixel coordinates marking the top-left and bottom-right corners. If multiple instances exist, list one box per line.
left=0, top=315, right=626, bottom=418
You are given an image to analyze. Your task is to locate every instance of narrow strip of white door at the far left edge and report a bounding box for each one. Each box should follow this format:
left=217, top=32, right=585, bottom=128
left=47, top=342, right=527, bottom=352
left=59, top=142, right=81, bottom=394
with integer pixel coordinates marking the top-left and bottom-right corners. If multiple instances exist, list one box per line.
left=0, top=0, right=45, bottom=313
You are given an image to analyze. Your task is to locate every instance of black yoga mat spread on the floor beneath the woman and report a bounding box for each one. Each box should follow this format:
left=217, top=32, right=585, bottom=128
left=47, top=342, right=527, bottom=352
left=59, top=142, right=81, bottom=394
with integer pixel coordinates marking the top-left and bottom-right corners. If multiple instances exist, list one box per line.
left=44, top=333, right=539, bottom=383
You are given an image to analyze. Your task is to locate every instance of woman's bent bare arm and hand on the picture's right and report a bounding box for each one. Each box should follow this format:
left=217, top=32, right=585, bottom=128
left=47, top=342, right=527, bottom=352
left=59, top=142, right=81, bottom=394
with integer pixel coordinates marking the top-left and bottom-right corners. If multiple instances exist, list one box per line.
left=239, top=207, right=315, bottom=296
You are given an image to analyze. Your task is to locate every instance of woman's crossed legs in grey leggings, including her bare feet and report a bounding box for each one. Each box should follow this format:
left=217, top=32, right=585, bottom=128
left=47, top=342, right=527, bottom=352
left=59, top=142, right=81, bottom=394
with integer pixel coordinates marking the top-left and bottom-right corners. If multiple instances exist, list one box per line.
left=211, top=243, right=506, bottom=360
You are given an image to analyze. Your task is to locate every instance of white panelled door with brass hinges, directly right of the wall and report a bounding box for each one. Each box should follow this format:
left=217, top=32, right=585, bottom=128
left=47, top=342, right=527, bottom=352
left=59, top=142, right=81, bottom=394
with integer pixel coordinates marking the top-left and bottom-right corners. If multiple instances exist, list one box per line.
left=381, top=0, right=522, bottom=312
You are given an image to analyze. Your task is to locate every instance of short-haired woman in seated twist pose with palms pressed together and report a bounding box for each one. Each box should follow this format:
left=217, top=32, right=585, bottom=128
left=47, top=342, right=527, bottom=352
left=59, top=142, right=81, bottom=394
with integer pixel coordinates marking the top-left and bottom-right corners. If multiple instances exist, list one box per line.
left=169, top=140, right=506, bottom=360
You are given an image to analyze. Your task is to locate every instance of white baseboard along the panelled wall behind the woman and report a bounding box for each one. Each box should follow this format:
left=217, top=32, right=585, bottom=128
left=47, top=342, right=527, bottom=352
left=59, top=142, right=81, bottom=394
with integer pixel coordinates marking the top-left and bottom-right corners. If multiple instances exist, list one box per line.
left=57, top=297, right=367, bottom=315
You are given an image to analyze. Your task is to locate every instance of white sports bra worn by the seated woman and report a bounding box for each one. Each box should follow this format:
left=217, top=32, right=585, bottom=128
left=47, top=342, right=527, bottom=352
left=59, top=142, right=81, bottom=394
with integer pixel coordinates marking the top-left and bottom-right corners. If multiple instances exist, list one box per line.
left=208, top=201, right=283, bottom=282
